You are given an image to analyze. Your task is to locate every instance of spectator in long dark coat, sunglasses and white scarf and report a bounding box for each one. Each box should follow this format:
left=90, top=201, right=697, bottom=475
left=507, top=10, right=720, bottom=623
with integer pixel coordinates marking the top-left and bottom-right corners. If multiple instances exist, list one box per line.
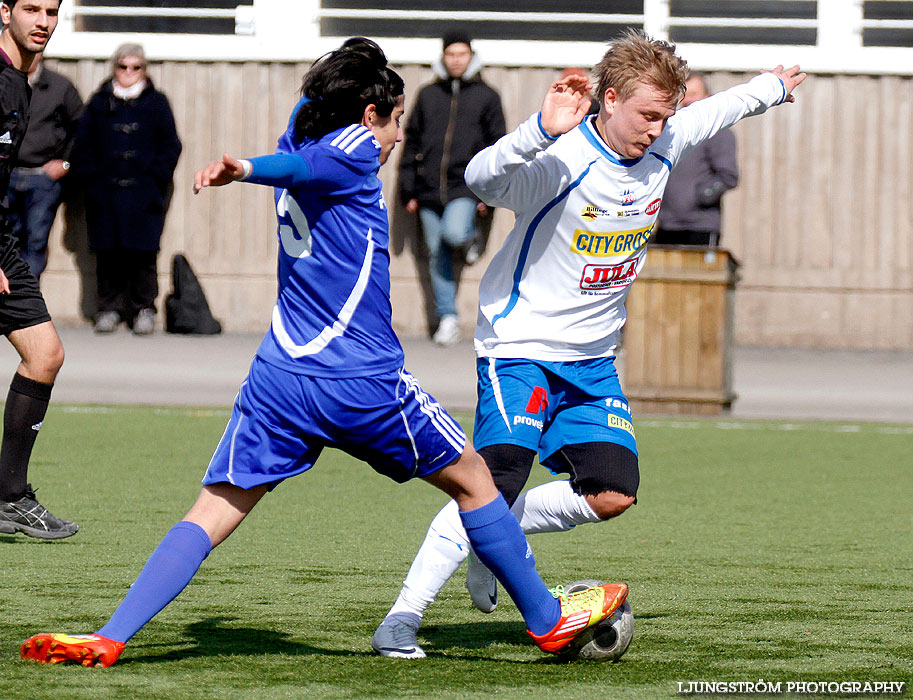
left=73, top=44, right=181, bottom=335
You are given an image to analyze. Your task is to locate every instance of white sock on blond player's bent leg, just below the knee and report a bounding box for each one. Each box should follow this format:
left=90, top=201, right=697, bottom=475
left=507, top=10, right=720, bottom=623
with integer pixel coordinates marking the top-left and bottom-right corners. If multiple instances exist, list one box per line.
left=510, top=479, right=602, bottom=535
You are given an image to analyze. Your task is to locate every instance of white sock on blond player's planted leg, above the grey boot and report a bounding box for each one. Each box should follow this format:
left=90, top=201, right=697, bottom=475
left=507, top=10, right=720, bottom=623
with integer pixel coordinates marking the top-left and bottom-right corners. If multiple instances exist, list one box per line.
left=387, top=501, right=469, bottom=618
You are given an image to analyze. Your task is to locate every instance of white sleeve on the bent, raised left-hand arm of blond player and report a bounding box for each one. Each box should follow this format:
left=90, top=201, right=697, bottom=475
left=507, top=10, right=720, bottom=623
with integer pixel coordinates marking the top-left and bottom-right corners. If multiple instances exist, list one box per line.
left=465, top=113, right=560, bottom=211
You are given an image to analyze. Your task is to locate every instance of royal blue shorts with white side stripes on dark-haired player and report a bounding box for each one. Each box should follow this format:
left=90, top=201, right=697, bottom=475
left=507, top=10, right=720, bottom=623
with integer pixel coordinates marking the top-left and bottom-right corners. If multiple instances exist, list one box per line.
left=203, top=357, right=466, bottom=489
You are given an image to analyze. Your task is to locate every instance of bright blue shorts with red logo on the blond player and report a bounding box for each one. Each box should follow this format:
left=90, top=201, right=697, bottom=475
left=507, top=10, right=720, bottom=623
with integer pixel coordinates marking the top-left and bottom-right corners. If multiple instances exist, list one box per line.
left=473, top=357, right=637, bottom=464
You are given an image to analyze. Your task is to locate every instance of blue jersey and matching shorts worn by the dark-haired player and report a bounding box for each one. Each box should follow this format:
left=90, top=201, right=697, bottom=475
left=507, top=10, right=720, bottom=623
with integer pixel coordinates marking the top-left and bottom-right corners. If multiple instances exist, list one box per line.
left=203, top=101, right=466, bottom=488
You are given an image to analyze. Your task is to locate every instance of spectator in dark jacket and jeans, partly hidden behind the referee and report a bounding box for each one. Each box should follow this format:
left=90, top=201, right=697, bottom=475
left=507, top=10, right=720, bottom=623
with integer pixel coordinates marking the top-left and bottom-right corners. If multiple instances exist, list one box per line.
left=8, top=54, right=82, bottom=277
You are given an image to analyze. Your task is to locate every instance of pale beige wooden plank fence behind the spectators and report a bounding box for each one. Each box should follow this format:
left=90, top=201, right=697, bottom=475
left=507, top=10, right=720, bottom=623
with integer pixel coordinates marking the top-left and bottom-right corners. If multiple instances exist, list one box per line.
left=42, top=57, right=913, bottom=349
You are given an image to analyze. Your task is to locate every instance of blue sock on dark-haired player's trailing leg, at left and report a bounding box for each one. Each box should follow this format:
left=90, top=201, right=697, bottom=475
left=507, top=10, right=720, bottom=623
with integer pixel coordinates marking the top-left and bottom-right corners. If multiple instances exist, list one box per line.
left=96, top=520, right=212, bottom=642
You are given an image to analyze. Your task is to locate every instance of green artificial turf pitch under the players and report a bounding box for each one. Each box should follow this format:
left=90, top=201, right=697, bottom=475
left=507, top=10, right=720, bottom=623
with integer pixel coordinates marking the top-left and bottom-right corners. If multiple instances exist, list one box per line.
left=0, top=407, right=913, bottom=700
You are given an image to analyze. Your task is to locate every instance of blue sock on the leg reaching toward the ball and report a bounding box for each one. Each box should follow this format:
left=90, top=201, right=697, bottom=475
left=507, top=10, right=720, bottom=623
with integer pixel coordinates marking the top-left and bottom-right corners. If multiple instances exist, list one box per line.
left=460, top=494, right=561, bottom=637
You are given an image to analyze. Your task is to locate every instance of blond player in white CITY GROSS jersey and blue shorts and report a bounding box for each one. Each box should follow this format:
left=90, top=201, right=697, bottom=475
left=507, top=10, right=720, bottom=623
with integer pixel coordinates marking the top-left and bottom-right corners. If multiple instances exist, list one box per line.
left=374, top=32, right=805, bottom=658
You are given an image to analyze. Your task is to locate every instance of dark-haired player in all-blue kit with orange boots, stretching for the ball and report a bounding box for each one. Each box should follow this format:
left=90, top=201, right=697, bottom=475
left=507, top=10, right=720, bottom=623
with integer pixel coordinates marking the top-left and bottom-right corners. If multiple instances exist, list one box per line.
left=20, top=39, right=627, bottom=666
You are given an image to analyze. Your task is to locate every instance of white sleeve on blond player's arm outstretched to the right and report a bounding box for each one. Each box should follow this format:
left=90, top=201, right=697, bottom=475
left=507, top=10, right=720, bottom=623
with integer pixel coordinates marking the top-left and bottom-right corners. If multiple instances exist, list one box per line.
left=666, top=73, right=786, bottom=166
